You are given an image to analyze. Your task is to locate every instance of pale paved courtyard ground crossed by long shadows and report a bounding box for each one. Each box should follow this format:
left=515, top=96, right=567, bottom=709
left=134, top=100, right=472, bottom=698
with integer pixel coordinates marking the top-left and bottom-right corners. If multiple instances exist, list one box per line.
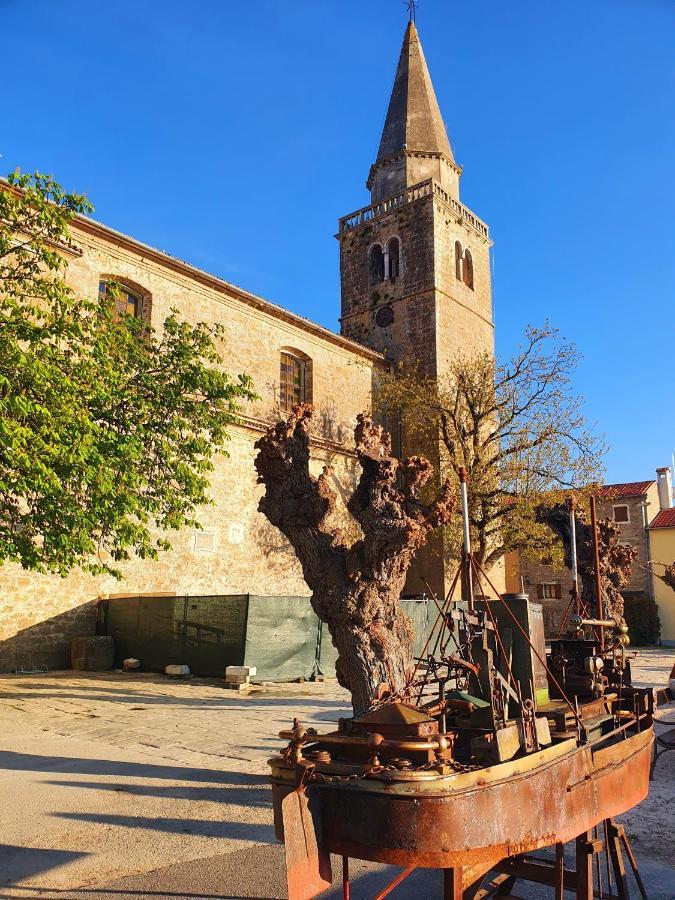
left=0, top=650, right=675, bottom=900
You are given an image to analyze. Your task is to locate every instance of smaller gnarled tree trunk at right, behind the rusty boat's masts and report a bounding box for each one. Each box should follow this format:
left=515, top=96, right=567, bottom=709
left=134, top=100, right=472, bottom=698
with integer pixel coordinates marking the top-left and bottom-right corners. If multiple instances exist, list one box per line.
left=538, top=503, right=637, bottom=624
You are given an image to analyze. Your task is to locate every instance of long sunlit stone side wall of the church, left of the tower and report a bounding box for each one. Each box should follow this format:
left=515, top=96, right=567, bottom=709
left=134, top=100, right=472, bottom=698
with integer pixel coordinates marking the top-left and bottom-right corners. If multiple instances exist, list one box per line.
left=0, top=216, right=382, bottom=671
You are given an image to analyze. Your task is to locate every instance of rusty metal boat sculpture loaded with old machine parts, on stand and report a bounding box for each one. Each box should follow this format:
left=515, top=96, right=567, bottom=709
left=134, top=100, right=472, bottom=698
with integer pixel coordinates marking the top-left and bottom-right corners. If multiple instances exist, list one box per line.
left=270, top=474, right=653, bottom=900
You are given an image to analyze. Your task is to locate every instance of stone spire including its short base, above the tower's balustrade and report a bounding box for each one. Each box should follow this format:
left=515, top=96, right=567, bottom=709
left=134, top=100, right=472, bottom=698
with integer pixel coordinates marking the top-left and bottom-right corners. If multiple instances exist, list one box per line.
left=368, top=19, right=458, bottom=202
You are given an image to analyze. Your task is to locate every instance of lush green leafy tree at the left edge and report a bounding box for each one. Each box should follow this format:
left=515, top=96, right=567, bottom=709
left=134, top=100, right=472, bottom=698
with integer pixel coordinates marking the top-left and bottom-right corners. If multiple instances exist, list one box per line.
left=0, top=172, right=255, bottom=577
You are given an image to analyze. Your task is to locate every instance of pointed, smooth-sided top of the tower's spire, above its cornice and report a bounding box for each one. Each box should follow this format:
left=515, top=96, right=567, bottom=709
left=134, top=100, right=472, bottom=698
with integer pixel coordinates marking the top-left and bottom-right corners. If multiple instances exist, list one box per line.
left=377, top=22, right=454, bottom=162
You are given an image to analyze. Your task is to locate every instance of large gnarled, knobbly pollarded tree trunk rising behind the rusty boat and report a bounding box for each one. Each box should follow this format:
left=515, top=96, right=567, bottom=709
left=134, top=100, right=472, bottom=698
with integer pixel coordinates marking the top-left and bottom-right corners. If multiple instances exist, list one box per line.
left=255, top=404, right=454, bottom=715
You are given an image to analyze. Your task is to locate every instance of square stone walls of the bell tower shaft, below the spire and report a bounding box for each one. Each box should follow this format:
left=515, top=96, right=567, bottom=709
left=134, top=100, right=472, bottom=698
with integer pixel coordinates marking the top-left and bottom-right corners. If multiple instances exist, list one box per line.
left=338, top=183, right=496, bottom=596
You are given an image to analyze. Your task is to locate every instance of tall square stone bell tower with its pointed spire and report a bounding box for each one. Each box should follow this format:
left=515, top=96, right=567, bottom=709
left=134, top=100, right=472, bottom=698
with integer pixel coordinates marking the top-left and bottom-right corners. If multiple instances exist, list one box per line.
left=337, top=21, right=494, bottom=596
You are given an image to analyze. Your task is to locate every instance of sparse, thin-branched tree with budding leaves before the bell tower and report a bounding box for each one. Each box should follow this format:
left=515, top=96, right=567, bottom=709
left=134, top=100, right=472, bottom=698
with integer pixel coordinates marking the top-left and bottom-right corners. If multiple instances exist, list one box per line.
left=377, top=325, right=605, bottom=566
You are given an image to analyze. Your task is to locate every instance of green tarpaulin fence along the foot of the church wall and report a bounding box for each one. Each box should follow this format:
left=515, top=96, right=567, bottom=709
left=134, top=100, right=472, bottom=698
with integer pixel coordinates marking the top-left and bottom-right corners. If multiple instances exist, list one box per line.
left=101, top=594, right=433, bottom=681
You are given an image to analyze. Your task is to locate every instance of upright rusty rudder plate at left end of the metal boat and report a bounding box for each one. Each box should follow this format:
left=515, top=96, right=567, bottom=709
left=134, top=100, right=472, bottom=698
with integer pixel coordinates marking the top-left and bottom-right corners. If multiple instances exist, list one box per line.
left=281, top=790, right=333, bottom=900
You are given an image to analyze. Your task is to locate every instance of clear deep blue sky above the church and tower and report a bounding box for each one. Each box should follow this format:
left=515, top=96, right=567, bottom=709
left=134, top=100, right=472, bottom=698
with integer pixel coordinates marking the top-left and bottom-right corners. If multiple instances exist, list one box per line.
left=0, top=0, right=675, bottom=481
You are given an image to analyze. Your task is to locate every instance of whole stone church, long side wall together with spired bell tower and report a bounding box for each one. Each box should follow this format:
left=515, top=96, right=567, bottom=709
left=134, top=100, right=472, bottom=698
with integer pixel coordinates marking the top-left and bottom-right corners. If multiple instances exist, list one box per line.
left=0, top=22, right=493, bottom=671
